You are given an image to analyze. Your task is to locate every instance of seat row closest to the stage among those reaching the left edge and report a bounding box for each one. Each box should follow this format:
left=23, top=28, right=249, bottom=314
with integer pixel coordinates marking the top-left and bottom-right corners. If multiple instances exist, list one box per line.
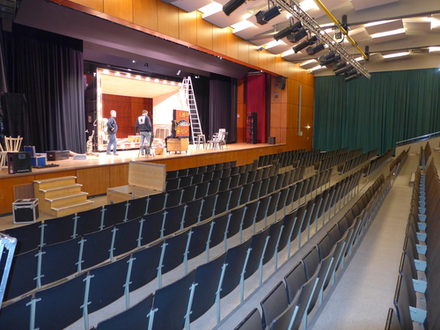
left=6, top=162, right=304, bottom=254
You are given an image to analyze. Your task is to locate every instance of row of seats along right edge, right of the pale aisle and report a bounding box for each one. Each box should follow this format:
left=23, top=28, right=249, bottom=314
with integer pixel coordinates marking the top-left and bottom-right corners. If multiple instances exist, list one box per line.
left=387, top=156, right=440, bottom=329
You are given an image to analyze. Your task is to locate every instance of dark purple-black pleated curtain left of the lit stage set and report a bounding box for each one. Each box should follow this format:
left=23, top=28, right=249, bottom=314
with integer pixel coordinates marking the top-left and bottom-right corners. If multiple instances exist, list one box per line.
left=4, top=25, right=86, bottom=152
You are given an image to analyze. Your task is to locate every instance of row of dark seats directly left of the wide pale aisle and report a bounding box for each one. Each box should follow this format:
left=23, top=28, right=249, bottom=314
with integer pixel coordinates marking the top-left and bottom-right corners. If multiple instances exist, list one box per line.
left=236, top=176, right=390, bottom=330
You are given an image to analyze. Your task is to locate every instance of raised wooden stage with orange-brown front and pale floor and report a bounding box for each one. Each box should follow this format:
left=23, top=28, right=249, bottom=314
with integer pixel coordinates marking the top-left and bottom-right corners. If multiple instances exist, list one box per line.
left=0, top=143, right=286, bottom=214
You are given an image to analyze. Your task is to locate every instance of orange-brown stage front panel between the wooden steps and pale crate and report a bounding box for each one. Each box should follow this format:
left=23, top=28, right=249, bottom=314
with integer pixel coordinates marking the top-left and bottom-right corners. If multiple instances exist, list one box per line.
left=76, top=166, right=110, bottom=196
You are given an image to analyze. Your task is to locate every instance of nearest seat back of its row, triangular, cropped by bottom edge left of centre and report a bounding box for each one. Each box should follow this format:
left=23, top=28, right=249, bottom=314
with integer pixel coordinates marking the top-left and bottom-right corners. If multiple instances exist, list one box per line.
left=96, top=294, right=154, bottom=330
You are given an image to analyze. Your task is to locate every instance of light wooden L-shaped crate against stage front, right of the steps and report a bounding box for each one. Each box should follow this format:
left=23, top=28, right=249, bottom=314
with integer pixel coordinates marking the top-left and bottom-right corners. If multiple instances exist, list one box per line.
left=107, top=162, right=166, bottom=203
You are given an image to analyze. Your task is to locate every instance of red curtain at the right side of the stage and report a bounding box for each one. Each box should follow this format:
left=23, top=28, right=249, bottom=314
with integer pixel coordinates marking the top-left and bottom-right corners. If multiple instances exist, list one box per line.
left=246, top=73, right=267, bottom=143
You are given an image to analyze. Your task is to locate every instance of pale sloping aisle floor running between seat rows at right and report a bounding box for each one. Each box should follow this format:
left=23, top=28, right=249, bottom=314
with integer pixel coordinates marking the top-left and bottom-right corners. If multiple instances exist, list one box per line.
left=312, top=154, right=418, bottom=330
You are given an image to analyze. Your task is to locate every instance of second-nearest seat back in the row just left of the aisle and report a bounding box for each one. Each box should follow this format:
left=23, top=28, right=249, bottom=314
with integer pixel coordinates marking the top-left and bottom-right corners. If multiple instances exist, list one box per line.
left=260, top=282, right=289, bottom=328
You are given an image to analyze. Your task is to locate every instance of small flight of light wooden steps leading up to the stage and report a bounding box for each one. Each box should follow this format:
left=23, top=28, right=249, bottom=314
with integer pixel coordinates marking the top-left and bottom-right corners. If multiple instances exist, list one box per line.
left=34, top=176, right=94, bottom=217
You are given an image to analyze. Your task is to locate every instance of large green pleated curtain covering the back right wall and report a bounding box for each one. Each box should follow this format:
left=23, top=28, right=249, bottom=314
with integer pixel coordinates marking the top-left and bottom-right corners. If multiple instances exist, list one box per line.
left=313, top=69, right=440, bottom=152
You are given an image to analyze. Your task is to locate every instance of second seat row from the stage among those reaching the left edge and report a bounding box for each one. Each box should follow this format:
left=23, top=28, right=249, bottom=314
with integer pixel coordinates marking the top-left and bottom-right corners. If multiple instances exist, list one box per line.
left=5, top=169, right=324, bottom=300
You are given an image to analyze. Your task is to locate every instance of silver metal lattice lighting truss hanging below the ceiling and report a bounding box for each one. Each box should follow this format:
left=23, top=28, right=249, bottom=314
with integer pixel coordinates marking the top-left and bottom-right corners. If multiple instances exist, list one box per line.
left=274, top=0, right=371, bottom=79
